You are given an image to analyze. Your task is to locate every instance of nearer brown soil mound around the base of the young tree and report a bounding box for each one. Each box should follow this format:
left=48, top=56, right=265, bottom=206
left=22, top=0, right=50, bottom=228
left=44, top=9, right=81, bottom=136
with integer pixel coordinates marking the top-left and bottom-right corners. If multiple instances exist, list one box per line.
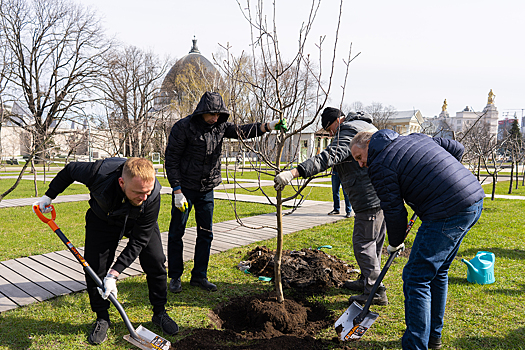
left=171, top=293, right=354, bottom=350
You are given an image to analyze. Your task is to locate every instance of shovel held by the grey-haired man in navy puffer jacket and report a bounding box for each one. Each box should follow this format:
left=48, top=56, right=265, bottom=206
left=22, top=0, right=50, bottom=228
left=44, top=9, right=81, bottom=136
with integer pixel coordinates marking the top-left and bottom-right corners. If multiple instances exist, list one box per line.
left=334, top=214, right=417, bottom=340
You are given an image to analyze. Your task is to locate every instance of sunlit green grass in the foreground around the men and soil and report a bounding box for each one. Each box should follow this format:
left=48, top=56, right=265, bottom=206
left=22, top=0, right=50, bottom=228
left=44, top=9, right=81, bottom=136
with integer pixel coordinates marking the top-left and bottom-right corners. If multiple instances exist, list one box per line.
left=0, top=194, right=525, bottom=350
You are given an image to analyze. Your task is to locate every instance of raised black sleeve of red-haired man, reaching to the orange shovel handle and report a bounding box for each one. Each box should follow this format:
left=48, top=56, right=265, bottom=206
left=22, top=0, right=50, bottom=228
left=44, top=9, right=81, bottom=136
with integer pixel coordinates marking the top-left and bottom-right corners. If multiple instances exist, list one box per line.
left=46, top=160, right=102, bottom=199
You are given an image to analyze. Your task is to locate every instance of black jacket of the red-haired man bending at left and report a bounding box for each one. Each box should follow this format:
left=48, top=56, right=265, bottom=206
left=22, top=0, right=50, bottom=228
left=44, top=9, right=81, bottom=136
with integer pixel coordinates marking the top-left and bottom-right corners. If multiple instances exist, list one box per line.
left=46, top=158, right=162, bottom=273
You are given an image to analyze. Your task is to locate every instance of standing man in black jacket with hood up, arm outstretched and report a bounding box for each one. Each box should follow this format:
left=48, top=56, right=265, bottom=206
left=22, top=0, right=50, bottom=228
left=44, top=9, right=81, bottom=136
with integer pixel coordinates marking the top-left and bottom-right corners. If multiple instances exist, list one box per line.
left=165, top=92, right=287, bottom=293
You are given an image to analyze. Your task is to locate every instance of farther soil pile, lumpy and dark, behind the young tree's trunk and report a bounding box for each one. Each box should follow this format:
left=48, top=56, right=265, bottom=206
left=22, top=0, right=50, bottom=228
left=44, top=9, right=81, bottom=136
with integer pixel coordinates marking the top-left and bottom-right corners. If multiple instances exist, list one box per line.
left=247, top=246, right=357, bottom=293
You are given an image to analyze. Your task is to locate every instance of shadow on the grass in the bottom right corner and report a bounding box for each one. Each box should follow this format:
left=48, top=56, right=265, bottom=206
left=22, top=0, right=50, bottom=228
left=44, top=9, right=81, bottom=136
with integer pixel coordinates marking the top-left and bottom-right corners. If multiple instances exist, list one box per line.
left=453, top=327, right=525, bottom=349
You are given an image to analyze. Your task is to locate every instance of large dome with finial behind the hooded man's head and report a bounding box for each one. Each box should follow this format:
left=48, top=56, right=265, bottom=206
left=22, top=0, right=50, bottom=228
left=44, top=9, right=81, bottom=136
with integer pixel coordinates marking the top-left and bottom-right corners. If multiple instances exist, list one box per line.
left=157, top=37, right=219, bottom=104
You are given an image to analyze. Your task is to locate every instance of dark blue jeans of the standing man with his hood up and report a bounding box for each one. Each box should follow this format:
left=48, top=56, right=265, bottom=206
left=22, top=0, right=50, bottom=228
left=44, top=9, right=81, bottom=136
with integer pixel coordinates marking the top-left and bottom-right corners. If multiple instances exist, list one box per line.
left=168, top=188, right=213, bottom=278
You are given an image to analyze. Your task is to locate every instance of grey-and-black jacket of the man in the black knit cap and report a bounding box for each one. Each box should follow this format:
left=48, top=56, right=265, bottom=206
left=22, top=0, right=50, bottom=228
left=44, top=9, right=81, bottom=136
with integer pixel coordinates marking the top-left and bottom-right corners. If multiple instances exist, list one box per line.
left=297, top=113, right=380, bottom=213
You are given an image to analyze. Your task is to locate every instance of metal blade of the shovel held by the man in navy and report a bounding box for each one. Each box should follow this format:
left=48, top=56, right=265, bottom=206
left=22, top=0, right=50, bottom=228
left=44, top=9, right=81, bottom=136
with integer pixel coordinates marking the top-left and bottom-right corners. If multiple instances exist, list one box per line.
left=334, top=301, right=379, bottom=341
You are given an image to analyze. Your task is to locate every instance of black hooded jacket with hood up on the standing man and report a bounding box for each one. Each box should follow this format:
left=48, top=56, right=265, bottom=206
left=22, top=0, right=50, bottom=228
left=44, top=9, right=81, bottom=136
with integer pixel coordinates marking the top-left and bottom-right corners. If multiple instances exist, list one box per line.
left=166, top=92, right=263, bottom=192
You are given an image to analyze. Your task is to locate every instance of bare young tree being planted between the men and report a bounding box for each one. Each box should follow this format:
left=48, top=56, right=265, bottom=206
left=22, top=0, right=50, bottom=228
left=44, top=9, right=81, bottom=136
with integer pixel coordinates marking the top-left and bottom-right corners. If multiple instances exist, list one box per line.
left=214, top=0, right=352, bottom=302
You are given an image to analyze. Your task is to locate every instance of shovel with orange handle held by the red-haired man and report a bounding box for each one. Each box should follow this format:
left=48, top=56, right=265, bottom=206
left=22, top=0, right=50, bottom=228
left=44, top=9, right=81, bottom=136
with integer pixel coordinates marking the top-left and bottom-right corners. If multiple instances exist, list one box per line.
left=33, top=205, right=171, bottom=350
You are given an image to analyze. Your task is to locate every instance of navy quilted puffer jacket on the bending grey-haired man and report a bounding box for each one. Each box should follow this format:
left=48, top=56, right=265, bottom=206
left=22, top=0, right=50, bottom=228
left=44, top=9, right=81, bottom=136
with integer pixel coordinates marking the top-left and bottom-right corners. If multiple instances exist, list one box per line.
left=367, top=130, right=485, bottom=246
